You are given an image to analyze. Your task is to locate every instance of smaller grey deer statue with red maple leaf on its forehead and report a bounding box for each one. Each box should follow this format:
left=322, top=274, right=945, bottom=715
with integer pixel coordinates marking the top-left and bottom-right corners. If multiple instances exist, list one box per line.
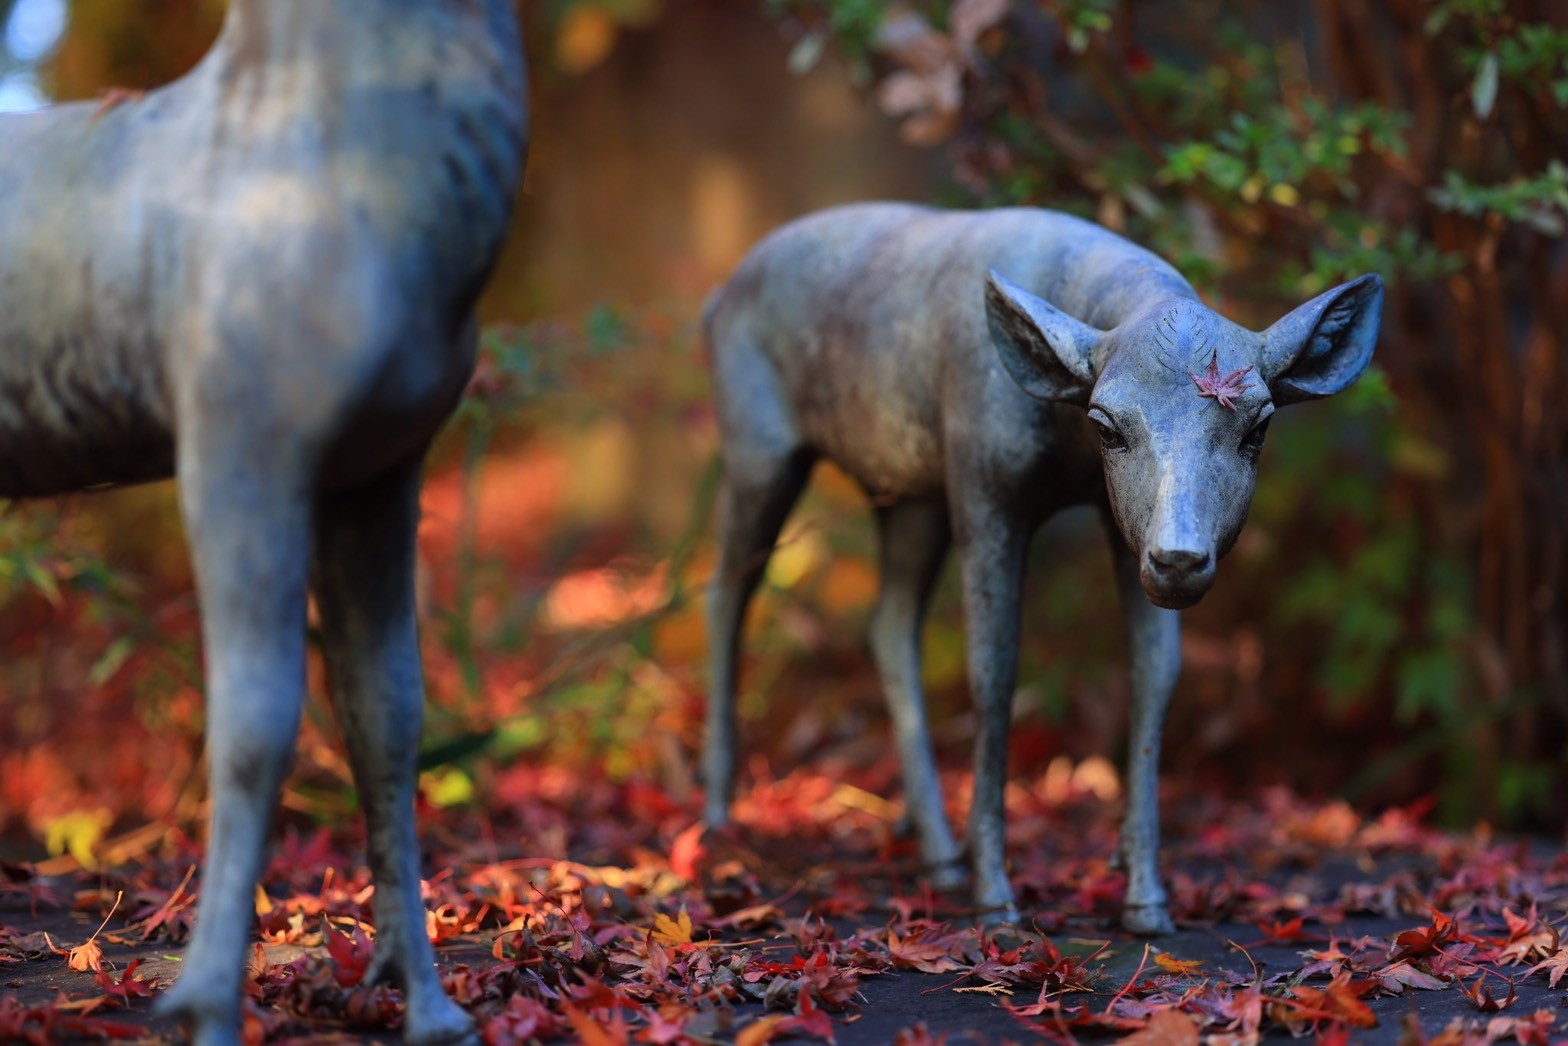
left=704, top=204, right=1383, bottom=935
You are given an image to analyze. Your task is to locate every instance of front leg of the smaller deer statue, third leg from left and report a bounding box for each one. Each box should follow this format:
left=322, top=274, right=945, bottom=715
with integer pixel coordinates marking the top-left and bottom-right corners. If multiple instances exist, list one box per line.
left=953, top=494, right=1029, bottom=922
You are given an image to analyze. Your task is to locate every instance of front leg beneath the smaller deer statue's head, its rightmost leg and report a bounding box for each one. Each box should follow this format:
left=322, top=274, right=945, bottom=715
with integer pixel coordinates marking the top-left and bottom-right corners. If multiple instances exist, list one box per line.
left=1112, top=530, right=1181, bottom=936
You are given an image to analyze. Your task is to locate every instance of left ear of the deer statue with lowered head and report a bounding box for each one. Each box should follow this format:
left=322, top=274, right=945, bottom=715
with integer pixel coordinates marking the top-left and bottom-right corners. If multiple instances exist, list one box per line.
left=985, top=270, right=1105, bottom=403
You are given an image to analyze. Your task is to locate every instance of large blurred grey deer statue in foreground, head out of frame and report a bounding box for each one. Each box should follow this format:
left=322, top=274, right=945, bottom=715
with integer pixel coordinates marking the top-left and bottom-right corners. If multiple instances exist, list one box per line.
left=0, top=0, right=527, bottom=1043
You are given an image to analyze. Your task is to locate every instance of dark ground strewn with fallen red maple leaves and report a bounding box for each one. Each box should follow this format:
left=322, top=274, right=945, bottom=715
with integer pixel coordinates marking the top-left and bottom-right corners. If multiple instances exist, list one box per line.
left=0, top=777, right=1568, bottom=1046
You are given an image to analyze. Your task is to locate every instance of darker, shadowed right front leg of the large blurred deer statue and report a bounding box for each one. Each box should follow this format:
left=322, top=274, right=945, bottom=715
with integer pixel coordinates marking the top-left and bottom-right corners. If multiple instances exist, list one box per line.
left=315, top=458, right=474, bottom=1043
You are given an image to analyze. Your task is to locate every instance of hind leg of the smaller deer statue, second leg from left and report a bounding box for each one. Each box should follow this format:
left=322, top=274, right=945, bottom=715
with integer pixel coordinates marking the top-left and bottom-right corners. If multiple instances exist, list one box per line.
left=872, top=502, right=966, bottom=889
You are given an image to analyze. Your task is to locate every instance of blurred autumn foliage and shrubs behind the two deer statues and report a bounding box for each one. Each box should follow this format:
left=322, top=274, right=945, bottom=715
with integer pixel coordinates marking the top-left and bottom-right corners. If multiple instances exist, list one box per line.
left=0, top=0, right=1568, bottom=865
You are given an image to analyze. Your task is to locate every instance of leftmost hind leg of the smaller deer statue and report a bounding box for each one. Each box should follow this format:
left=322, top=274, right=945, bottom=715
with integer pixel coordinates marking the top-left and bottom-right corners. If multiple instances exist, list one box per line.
left=702, top=447, right=811, bottom=828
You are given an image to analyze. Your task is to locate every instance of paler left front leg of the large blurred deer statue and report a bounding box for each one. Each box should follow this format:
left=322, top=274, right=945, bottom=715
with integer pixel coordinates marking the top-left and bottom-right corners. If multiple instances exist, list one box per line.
left=162, top=438, right=310, bottom=1046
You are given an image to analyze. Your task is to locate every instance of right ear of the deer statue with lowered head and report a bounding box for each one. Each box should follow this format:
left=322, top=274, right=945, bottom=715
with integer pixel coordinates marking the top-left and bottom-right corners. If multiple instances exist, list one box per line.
left=1259, top=274, right=1383, bottom=406
